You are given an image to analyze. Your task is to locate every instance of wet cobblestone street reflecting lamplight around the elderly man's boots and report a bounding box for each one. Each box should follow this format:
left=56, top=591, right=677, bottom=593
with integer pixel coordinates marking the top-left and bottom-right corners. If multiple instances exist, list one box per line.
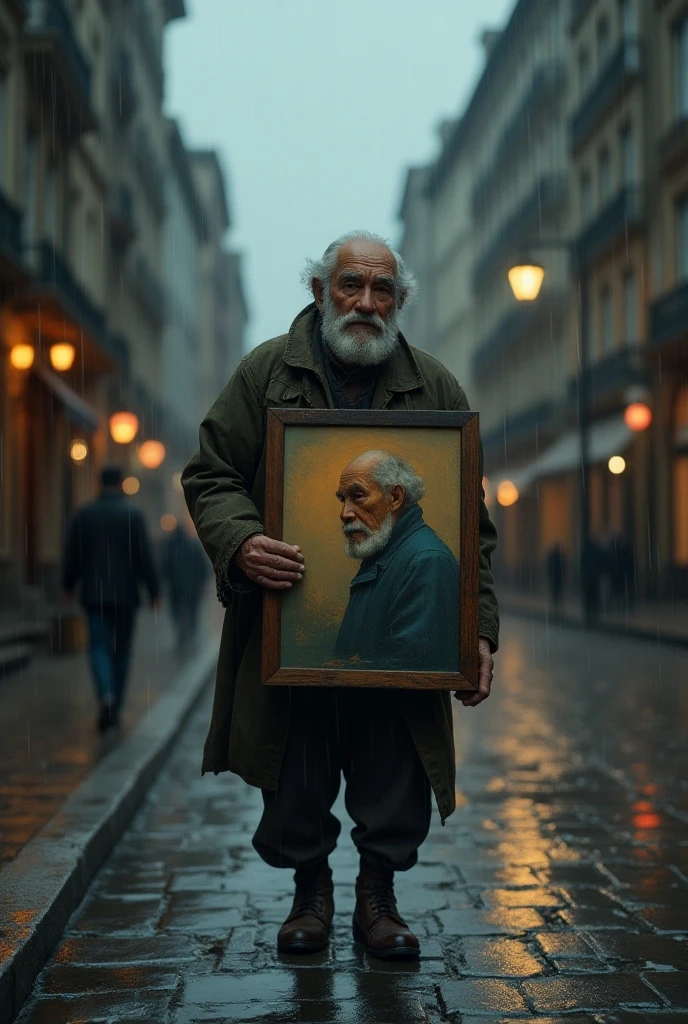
left=13, top=620, right=688, bottom=1024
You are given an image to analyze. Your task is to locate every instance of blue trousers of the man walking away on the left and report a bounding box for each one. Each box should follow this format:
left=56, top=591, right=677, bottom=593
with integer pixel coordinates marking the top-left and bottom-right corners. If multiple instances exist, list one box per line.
left=86, top=606, right=136, bottom=710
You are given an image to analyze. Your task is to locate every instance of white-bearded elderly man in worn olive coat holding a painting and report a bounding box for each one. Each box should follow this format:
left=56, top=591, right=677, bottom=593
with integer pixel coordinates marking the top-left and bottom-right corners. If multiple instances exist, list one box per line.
left=182, top=231, right=499, bottom=958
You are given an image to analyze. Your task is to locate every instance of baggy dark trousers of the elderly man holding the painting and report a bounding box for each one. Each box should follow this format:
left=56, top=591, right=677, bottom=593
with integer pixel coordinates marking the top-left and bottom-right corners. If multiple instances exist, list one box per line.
left=253, top=687, right=432, bottom=871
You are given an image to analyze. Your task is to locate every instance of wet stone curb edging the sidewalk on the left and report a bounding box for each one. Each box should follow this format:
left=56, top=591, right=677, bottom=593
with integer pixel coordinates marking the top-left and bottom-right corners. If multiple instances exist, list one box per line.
left=0, top=648, right=217, bottom=1024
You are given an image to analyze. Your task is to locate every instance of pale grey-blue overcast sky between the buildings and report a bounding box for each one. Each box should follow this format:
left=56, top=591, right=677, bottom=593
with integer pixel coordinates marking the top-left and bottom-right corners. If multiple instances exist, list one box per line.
left=166, top=0, right=514, bottom=346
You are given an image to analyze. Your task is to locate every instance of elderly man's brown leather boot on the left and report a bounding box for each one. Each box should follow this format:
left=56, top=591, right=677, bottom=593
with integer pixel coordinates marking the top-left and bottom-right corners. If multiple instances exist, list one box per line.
left=277, top=861, right=335, bottom=955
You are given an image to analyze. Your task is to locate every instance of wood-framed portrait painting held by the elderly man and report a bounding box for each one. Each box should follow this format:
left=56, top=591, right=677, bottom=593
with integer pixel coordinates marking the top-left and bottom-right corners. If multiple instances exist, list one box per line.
left=262, top=409, right=480, bottom=693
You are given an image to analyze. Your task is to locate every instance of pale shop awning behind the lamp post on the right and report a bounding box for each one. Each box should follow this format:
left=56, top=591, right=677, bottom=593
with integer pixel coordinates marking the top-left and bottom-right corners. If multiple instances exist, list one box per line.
left=501, top=416, right=636, bottom=490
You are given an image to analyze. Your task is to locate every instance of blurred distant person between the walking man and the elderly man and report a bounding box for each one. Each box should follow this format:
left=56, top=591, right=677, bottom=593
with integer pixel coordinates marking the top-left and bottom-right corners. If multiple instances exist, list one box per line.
left=161, top=520, right=211, bottom=655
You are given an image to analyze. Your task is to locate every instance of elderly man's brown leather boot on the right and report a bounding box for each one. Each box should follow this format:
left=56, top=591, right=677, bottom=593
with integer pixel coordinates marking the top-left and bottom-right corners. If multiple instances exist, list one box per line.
left=353, top=862, right=421, bottom=959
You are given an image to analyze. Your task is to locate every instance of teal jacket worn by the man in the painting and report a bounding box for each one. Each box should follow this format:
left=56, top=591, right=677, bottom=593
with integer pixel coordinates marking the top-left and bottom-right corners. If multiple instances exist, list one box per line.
left=334, top=505, right=459, bottom=672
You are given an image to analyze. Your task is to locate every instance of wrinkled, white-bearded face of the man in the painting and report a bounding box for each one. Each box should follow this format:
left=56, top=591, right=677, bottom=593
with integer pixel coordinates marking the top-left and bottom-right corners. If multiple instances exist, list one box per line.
left=336, top=459, right=404, bottom=558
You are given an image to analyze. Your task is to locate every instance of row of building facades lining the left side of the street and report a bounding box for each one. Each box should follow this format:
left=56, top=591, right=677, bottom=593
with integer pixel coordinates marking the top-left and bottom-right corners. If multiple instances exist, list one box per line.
left=0, top=0, right=246, bottom=608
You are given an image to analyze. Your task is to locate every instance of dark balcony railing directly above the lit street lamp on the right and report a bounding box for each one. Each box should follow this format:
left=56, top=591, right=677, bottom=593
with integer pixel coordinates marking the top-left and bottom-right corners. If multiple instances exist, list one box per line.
left=473, top=174, right=567, bottom=289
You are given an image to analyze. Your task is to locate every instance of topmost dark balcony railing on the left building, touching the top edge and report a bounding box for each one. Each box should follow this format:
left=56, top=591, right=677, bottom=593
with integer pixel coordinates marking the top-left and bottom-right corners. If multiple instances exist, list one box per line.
left=23, top=0, right=97, bottom=134
